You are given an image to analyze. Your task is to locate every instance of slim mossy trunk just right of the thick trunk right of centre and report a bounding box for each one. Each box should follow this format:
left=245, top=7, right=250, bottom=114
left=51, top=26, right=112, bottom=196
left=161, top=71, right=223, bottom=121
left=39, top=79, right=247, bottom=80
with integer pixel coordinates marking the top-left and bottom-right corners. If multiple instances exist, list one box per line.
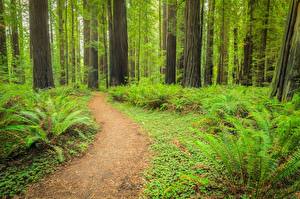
left=204, top=0, right=215, bottom=86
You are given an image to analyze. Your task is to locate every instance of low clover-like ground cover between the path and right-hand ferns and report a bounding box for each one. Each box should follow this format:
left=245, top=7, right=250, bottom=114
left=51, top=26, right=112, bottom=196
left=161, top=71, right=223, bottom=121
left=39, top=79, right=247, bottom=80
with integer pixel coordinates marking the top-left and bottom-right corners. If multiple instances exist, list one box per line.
left=114, top=104, right=213, bottom=198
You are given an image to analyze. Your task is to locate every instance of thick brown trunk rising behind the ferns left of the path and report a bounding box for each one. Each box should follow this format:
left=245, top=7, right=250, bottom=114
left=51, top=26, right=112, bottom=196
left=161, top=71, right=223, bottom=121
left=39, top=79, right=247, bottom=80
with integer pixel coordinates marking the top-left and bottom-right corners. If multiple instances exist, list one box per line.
left=29, top=0, right=54, bottom=89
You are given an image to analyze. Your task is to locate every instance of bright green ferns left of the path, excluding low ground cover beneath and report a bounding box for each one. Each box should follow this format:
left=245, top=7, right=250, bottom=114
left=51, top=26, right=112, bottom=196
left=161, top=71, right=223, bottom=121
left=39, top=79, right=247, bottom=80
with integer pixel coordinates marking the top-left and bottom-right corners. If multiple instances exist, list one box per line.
left=0, top=85, right=95, bottom=159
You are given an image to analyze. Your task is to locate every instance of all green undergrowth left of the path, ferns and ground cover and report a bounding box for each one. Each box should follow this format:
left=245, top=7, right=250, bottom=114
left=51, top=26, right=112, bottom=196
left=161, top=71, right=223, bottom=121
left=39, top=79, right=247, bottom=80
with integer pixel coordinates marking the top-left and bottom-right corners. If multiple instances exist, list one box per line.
left=0, top=85, right=98, bottom=197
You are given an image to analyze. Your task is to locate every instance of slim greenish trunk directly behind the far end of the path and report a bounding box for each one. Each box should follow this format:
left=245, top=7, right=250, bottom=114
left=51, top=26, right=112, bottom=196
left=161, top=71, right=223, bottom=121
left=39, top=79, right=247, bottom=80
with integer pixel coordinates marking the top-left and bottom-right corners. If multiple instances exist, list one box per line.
left=88, top=6, right=99, bottom=89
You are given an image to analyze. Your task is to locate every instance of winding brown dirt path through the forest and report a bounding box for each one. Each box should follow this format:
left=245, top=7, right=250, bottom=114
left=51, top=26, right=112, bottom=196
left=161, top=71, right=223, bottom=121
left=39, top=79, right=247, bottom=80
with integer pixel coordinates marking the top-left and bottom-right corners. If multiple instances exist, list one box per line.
left=27, top=94, right=148, bottom=199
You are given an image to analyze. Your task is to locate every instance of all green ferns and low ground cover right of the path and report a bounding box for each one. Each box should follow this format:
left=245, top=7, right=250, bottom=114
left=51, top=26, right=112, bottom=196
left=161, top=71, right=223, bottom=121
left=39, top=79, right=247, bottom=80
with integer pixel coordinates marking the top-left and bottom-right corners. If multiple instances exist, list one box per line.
left=110, top=83, right=300, bottom=198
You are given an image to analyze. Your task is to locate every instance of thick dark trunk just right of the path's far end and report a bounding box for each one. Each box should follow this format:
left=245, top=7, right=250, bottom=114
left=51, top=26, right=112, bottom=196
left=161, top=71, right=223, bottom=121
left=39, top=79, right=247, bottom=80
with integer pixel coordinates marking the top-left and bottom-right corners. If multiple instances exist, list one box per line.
left=110, top=0, right=128, bottom=86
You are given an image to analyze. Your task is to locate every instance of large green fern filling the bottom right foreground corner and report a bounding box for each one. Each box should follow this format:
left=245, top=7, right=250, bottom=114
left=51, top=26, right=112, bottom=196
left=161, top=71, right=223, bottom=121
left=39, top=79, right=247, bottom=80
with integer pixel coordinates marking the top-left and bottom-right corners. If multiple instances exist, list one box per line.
left=197, top=129, right=300, bottom=198
